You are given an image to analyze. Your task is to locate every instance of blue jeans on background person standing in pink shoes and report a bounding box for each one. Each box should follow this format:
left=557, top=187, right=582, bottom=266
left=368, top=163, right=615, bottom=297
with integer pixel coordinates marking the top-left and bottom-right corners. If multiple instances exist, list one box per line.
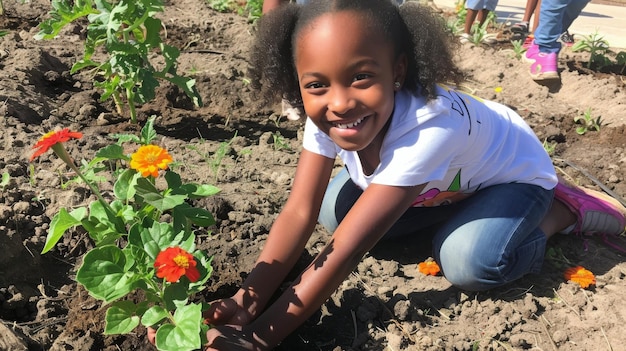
left=535, top=0, right=590, bottom=53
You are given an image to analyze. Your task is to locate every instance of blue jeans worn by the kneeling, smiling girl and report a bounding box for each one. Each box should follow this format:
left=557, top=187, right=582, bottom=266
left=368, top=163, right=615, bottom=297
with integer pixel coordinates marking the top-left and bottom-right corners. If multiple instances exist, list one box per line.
left=319, top=168, right=554, bottom=291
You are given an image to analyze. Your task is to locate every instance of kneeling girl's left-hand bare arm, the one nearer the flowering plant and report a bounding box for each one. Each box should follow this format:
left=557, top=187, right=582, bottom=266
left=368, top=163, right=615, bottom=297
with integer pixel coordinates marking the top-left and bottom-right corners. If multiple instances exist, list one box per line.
left=206, top=150, right=334, bottom=325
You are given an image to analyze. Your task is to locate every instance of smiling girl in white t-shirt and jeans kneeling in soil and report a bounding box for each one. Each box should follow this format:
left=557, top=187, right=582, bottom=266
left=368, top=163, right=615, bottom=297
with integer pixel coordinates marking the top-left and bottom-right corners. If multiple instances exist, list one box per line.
left=202, top=0, right=626, bottom=350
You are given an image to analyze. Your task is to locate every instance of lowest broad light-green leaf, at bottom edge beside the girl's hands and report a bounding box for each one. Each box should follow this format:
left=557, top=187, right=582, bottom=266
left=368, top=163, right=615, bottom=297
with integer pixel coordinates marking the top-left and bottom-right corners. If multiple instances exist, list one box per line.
left=156, top=304, right=202, bottom=351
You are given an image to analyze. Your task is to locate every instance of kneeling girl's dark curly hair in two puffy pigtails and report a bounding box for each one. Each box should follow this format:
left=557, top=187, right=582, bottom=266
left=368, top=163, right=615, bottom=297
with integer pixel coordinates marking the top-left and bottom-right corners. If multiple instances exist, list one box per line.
left=249, top=0, right=462, bottom=103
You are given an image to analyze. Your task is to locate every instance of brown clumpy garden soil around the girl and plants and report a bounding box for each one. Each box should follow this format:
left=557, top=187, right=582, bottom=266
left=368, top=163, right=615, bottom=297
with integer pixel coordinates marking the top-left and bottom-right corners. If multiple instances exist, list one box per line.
left=0, top=0, right=626, bottom=351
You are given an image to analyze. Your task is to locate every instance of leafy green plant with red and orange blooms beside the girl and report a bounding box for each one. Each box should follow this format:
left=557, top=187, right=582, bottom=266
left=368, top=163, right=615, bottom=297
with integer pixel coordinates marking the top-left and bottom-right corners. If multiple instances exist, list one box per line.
left=31, top=117, right=219, bottom=351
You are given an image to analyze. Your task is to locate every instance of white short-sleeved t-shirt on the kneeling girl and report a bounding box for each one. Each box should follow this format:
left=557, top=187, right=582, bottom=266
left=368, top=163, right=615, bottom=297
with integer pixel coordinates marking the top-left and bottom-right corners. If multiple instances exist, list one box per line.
left=303, top=86, right=557, bottom=206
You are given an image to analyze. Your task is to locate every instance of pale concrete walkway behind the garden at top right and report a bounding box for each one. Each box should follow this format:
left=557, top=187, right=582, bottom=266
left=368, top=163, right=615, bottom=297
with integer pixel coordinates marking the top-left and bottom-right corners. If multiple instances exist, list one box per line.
left=434, top=0, right=626, bottom=51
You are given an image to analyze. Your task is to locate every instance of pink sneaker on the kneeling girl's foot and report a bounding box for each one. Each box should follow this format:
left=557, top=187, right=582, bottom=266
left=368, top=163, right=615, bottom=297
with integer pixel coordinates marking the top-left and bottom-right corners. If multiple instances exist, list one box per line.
left=554, top=177, right=626, bottom=236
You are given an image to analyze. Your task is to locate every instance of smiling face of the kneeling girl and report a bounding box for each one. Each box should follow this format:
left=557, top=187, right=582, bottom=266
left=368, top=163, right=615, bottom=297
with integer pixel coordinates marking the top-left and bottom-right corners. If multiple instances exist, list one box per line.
left=295, top=11, right=406, bottom=151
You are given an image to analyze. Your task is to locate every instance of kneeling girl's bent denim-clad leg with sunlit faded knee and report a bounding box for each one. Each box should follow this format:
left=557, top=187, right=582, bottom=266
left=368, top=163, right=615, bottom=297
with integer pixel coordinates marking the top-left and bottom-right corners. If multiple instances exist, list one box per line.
left=433, top=183, right=554, bottom=290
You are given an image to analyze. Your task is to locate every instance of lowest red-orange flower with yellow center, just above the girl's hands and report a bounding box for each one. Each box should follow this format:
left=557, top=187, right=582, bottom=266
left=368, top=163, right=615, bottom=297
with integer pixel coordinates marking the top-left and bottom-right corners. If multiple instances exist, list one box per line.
left=154, top=246, right=200, bottom=283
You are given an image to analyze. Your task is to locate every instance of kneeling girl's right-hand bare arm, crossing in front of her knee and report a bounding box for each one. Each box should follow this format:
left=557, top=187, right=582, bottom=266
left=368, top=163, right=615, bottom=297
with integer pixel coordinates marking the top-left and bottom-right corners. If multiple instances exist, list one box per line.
left=232, top=179, right=424, bottom=346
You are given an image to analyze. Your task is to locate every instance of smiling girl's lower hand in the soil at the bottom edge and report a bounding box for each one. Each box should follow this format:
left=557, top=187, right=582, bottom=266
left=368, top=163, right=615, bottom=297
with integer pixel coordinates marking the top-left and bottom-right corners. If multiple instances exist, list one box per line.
left=205, top=325, right=269, bottom=351
